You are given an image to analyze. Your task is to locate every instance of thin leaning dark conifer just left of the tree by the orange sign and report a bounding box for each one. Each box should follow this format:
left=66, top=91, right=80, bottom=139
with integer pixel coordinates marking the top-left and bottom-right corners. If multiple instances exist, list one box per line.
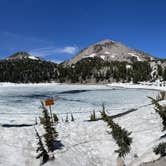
left=35, top=129, right=49, bottom=164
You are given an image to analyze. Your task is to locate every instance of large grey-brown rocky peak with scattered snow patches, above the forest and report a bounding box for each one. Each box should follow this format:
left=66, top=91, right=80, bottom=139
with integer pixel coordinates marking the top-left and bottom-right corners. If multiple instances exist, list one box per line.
left=65, top=40, right=155, bottom=65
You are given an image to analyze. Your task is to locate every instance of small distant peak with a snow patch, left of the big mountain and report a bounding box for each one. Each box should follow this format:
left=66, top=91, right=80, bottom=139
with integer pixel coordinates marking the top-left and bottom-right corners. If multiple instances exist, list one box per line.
left=6, top=52, right=40, bottom=60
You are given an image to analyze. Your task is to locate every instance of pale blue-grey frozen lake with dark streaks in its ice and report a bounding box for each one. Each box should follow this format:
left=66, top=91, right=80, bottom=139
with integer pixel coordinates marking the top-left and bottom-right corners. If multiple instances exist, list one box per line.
left=0, top=84, right=158, bottom=124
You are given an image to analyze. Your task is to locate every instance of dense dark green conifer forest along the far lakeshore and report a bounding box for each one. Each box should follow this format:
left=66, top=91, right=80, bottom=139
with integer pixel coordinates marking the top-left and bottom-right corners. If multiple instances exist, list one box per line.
left=0, top=57, right=166, bottom=83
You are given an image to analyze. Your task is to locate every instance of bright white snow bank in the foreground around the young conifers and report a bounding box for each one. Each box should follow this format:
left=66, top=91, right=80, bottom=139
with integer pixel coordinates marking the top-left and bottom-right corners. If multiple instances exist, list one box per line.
left=0, top=99, right=163, bottom=166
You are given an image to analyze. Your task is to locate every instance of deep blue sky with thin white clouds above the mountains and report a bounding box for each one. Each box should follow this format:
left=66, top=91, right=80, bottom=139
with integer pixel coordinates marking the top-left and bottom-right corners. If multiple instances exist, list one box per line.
left=0, top=0, right=166, bottom=62
